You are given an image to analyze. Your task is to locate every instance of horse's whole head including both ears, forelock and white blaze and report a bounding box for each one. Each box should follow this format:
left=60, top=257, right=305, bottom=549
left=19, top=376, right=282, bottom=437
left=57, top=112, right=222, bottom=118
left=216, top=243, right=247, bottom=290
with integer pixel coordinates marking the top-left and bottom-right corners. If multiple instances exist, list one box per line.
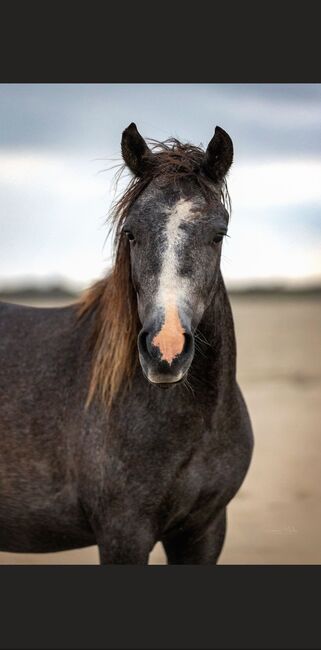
left=121, top=124, right=233, bottom=386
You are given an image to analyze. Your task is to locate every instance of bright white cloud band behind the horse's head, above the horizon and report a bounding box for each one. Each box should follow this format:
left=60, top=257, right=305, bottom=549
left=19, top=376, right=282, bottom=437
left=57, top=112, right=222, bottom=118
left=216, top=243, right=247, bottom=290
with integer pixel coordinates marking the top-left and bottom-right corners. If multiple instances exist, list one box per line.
left=0, top=150, right=321, bottom=285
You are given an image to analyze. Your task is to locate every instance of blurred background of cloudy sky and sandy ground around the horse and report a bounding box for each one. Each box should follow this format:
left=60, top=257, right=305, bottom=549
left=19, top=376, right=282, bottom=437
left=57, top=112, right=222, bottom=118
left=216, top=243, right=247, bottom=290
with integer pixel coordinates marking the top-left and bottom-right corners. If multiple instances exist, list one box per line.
left=0, top=84, right=321, bottom=564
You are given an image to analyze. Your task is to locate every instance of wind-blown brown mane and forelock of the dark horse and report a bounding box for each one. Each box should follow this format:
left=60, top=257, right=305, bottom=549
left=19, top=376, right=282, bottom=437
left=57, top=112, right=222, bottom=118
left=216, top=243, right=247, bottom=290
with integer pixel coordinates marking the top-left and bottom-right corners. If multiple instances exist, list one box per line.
left=78, top=138, right=230, bottom=406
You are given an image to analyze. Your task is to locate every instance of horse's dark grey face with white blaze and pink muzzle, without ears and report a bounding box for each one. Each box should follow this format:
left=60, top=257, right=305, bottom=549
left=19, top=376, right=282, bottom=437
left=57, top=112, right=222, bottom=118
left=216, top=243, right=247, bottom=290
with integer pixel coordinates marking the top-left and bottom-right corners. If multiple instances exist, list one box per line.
left=123, top=121, right=228, bottom=386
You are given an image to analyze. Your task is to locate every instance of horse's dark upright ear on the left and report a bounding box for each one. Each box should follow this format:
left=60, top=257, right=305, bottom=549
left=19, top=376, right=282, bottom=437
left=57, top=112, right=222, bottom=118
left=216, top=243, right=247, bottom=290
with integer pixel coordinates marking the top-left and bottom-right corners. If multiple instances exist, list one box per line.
left=121, top=122, right=153, bottom=176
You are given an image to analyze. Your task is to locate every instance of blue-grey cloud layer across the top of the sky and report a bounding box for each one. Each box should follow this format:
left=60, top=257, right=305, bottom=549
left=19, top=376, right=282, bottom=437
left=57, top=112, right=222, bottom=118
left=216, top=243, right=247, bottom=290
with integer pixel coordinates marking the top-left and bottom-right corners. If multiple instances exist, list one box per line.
left=0, top=84, right=321, bottom=160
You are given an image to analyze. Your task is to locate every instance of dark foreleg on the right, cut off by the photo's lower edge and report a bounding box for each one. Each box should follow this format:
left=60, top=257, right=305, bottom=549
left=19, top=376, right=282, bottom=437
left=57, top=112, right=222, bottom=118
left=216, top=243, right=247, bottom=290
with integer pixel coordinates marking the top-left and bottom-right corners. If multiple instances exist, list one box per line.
left=162, top=509, right=226, bottom=564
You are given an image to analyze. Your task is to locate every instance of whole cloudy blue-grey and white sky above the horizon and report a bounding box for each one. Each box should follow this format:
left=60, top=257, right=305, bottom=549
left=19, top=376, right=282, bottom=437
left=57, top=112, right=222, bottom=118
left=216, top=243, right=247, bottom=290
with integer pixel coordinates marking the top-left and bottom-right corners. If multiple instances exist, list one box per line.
left=0, top=84, right=321, bottom=289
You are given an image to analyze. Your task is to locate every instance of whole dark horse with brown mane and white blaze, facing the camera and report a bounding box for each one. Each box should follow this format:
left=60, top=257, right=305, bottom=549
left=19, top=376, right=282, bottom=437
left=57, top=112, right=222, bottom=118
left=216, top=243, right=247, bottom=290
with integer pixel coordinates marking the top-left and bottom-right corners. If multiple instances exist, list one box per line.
left=0, top=123, right=253, bottom=565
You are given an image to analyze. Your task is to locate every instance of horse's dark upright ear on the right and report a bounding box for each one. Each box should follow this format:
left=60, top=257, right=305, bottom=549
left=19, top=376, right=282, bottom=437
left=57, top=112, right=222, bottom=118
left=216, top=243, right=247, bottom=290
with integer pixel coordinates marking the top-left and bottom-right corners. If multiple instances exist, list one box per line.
left=202, top=126, right=233, bottom=183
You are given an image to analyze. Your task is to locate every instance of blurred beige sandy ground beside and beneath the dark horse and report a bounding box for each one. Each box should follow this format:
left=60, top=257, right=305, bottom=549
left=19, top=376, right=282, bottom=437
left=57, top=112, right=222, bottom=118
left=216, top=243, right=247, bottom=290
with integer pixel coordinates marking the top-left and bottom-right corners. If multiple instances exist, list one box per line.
left=0, top=297, right=321, bottom=564
